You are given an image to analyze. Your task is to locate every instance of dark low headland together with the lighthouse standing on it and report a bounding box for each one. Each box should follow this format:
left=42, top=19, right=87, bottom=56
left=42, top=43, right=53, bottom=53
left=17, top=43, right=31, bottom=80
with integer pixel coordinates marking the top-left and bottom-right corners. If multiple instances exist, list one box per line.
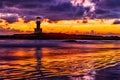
left=0, top=17, right=120, bottom=40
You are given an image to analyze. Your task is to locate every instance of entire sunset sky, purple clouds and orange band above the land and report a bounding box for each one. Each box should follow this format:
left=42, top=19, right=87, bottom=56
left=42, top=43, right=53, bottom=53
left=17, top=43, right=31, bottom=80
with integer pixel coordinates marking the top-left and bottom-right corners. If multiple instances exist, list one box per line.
left=0, top=0, right=120, bottom=35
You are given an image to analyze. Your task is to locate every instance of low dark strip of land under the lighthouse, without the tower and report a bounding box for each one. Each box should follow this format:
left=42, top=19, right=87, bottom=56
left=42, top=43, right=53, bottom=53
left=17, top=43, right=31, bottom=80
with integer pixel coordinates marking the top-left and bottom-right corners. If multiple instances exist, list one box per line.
left=0, top=33, right=120, bottom=40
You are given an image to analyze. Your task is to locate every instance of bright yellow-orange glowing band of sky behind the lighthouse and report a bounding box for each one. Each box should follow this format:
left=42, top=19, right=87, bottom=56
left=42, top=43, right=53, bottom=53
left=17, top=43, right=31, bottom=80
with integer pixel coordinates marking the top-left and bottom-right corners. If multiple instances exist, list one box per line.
left=0, top=18, right=120, bottom=34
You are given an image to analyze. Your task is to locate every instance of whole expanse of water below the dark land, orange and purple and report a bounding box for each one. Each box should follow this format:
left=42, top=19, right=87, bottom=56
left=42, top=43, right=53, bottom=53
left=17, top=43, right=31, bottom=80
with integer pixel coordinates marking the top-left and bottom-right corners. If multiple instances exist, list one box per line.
left=0, top=39, right=120, bottom=80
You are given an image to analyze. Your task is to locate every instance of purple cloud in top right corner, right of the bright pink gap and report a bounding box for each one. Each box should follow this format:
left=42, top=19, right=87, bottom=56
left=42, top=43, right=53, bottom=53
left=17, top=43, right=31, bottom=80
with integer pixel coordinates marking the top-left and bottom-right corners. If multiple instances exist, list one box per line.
left=96, top=0, right=120, bottom=18
